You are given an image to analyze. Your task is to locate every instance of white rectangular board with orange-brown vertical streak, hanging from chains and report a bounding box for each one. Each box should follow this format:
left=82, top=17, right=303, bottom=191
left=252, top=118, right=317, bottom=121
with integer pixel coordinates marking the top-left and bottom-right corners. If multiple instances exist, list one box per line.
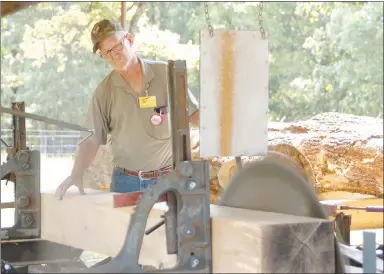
left=200, top=30, right=269, bottom=157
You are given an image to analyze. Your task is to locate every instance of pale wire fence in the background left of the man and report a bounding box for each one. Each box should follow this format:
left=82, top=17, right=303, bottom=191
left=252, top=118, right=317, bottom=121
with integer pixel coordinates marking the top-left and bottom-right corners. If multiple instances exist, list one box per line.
left=1, top=129, right=81, bottom=157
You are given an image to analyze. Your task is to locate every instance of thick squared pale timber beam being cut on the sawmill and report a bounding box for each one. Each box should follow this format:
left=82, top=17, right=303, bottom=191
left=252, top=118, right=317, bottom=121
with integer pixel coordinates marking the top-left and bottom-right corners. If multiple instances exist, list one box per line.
left=41, top=188, right=335, bottom=273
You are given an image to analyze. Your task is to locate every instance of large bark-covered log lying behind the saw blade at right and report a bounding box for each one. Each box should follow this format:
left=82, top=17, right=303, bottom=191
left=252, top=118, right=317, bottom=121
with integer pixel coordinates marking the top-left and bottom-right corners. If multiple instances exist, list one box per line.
left=269, top=113, right=383, bottom=198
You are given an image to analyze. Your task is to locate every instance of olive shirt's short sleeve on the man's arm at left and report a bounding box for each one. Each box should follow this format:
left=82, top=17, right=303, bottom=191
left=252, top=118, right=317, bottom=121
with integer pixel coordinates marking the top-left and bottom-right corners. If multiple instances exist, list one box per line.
left=84, top=89, right=109, bottom=145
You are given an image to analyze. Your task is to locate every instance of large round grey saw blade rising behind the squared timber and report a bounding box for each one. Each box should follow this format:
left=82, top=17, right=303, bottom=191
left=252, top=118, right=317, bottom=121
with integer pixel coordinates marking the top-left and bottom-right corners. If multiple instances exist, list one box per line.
left=217, top=153, right=346, bottom=273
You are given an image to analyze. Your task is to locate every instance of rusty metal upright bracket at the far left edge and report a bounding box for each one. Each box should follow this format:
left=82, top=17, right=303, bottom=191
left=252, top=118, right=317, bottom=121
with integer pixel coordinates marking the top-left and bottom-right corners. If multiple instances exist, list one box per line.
left=0, top=102, right=41, bottom=239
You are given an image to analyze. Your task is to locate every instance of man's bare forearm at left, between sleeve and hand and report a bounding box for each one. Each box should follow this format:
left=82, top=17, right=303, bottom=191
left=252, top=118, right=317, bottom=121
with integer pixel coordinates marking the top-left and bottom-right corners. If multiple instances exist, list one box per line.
left=71, top=139, right=100, bottom=178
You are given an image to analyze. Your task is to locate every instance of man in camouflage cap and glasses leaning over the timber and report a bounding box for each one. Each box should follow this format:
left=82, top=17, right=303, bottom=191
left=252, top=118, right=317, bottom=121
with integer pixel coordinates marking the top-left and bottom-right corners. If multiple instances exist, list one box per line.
left=56, top=20, right=199, bottom=199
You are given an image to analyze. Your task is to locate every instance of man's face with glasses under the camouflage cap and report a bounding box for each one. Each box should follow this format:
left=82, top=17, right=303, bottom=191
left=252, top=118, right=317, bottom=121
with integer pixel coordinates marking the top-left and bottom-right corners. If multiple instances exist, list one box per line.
left=99, top=33, right=134, bottom=71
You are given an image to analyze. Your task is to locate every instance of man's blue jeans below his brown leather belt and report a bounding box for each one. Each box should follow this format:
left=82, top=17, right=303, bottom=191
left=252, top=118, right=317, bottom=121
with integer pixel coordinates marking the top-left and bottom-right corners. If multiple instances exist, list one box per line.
left=109, top=168, right=156, bottom=193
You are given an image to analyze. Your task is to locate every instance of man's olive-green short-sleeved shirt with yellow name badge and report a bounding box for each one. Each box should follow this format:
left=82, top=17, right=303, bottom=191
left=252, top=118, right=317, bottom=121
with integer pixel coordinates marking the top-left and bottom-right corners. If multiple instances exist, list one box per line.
left=86, top=59, right=198, bottom=171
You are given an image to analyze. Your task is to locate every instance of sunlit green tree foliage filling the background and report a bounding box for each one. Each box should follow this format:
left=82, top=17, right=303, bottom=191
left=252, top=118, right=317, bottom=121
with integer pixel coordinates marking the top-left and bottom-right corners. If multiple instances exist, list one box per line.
left=1, top=2, right=383, bottom=131
